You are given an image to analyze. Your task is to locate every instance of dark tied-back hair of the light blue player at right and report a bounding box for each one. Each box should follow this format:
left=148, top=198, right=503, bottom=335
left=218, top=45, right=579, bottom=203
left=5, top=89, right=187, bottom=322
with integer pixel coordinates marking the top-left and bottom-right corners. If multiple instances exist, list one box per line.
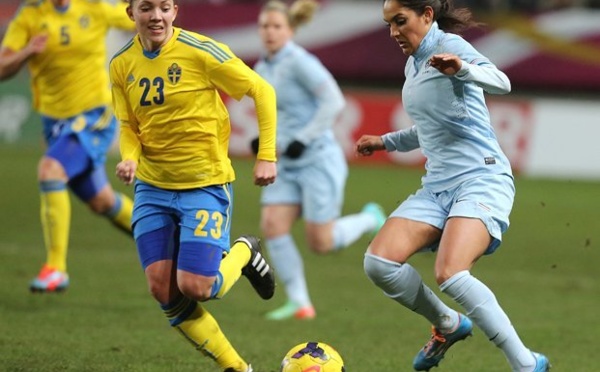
left=384, top=0, right=481, bottom=33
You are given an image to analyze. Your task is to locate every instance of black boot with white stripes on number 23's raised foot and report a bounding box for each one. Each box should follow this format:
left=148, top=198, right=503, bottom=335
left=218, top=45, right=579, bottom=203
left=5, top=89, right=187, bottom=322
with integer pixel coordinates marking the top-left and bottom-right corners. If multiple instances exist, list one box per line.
left=234, top=235, right=275, bottom=300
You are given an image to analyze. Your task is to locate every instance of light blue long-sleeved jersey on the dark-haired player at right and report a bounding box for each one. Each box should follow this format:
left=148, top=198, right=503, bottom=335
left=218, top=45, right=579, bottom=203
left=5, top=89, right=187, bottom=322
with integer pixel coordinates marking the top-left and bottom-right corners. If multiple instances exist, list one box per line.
left=382, top=23, right=512, bottom=192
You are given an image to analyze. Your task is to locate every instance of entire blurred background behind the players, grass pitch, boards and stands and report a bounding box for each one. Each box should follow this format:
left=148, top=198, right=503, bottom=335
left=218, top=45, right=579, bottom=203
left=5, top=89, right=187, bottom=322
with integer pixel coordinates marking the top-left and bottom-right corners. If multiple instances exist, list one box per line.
left=0, top=0, right=600, bottom=372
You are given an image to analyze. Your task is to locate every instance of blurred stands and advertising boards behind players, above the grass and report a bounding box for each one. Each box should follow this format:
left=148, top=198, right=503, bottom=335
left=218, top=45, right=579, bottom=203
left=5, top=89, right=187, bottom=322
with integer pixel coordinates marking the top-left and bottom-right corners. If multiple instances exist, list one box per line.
left=0, top=0, right=600, bottom=179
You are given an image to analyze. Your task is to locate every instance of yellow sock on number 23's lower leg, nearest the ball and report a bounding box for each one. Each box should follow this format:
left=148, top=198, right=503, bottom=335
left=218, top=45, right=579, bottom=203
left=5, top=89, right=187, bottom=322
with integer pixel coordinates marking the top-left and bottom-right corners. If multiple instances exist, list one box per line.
left=163, top=296, right=248, bottom=371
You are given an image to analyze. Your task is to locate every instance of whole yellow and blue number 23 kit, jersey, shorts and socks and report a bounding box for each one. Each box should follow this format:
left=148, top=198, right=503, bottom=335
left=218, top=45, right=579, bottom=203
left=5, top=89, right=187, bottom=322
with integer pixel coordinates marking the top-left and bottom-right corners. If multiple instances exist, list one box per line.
left=110, top=28, right=276, bottom=371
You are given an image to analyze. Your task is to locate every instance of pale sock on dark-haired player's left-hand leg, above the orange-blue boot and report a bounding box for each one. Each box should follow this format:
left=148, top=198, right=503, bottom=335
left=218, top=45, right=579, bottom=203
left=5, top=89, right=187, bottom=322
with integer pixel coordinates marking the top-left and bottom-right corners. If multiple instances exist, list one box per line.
left=364, top=253, right=458, bottom=332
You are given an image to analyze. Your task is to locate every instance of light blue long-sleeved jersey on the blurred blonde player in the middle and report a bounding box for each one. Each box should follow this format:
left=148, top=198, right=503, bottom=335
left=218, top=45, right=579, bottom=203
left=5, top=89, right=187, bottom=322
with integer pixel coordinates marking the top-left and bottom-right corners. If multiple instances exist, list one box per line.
left=254, top=41, right=345, bottom=168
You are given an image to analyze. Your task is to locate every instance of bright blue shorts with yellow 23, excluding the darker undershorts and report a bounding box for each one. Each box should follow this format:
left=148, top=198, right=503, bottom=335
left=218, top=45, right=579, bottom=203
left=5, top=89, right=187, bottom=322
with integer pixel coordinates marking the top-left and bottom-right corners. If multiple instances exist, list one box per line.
left=132, top=180, right=233, bottom=252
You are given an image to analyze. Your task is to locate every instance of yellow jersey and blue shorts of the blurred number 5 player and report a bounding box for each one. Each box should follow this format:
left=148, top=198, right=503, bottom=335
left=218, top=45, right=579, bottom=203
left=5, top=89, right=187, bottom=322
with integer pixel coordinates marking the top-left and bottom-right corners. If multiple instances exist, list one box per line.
left=2, top=0, right=135, bottom=171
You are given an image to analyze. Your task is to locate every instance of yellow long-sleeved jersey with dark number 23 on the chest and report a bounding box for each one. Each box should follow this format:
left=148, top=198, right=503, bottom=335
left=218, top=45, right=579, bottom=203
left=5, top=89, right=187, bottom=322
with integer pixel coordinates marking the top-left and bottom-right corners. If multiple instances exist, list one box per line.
left=110, top=28, right=277, bottom=189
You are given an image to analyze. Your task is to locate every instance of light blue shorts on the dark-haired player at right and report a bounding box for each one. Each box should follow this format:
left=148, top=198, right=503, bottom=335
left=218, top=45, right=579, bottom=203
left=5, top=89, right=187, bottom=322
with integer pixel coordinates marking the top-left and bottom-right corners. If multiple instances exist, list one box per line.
left=390, top=175, right=515, bottom=254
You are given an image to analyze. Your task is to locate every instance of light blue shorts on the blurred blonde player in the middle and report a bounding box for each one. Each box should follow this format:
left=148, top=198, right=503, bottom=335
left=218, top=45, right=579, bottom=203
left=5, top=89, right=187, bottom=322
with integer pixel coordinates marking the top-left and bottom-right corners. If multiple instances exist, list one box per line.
left=261, top=151, right=348, bottom=223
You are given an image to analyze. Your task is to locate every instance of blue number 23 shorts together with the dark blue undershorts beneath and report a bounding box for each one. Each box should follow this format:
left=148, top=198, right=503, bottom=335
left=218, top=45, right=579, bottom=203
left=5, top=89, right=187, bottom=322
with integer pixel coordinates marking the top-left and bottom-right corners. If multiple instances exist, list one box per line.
left=132, top=180, right=233, bottom=276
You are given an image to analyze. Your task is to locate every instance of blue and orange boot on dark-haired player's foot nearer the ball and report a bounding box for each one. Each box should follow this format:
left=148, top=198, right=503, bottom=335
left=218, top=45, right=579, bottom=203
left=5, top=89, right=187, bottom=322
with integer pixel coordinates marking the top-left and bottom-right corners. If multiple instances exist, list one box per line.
left=413, top=314, right=473, bottom=371
